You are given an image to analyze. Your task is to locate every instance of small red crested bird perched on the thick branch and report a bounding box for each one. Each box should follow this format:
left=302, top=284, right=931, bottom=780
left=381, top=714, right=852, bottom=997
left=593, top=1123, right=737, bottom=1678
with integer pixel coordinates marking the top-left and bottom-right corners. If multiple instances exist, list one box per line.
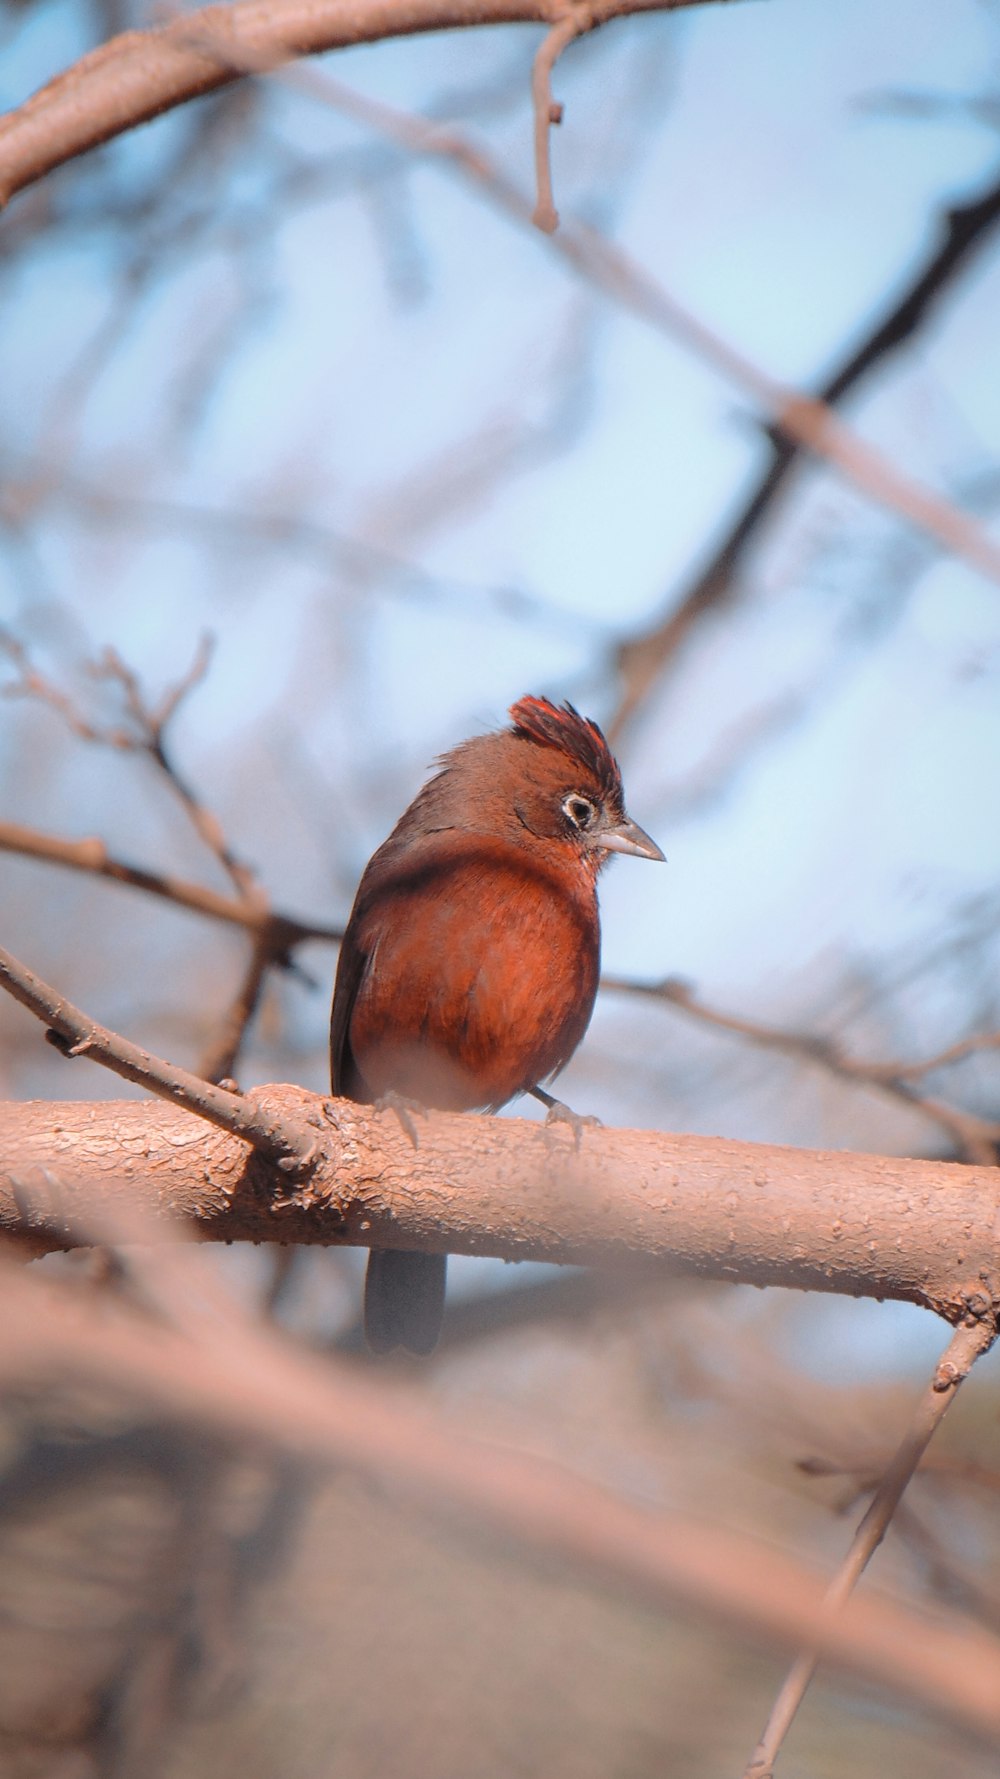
left=331, top=697, right=664, bottom=1352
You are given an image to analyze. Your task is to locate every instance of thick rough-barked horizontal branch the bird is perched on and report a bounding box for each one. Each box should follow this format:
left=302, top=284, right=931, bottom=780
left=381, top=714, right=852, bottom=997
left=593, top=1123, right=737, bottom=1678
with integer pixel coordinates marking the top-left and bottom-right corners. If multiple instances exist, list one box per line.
left=0, top=1087, right=1000, bottom=1320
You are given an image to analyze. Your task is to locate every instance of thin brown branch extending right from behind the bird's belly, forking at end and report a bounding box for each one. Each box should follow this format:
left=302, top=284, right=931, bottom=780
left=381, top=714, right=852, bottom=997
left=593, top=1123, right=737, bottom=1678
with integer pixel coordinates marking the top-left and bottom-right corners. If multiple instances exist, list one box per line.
left=601, top=977, right=1000, bottom=1163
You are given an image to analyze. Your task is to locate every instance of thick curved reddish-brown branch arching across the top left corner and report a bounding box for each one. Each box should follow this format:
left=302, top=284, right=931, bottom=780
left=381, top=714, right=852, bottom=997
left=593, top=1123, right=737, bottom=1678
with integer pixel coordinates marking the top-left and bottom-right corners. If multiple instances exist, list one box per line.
left=0, top=0, right=705, bottom=208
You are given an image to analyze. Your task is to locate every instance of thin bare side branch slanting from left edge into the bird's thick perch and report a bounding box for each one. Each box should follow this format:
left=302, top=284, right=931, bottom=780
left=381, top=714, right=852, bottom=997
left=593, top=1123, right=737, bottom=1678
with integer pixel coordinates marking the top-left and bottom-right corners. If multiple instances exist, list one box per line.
left=0, top=950, right=317, bottom=1172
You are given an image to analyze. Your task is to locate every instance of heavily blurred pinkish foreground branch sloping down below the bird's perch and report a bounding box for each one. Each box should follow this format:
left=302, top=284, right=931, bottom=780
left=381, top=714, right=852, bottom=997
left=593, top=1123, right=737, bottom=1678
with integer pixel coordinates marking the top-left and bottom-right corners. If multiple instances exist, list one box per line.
left=0, top=1251, right=1000, bottom=1742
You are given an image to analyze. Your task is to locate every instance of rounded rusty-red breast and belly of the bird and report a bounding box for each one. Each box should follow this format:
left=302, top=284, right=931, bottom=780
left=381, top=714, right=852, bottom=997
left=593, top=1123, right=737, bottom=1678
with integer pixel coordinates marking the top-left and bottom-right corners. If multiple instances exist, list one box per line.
left=349, top=843, right=600, bottom=1110
